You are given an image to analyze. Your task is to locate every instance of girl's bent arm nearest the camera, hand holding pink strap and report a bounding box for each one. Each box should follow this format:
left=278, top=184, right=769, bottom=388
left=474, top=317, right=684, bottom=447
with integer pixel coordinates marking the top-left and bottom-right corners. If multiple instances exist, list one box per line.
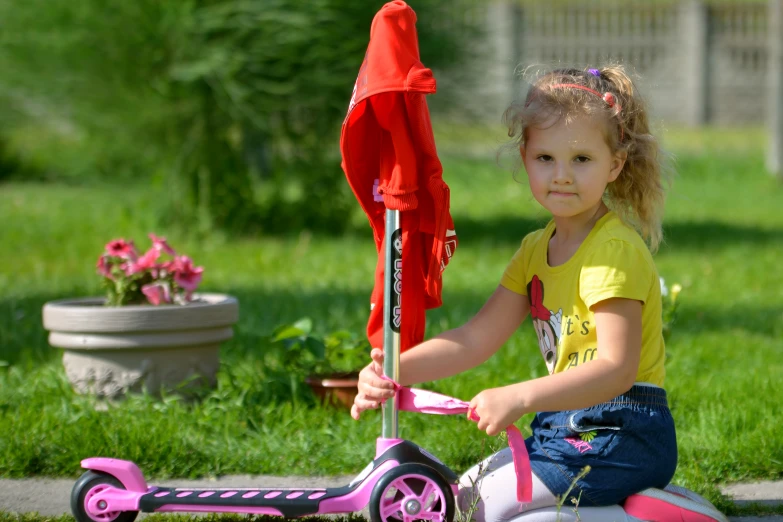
left=471, top=298, right=642, bottom=435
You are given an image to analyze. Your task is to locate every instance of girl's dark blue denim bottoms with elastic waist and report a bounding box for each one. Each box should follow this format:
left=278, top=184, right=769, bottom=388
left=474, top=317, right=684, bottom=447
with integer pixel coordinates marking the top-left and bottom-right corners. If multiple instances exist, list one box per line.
left=525, top=385, right=677, bottom=506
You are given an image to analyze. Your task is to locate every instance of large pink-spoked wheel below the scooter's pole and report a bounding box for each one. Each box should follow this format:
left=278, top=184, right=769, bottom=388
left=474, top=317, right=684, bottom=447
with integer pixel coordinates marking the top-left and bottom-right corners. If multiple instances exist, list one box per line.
left=369, top=463, right=454, bottom=522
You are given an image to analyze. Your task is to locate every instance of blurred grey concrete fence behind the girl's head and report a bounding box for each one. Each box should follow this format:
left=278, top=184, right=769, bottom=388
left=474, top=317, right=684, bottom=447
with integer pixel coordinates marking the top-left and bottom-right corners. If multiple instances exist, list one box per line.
left=428, top=0, right=783, bottom=175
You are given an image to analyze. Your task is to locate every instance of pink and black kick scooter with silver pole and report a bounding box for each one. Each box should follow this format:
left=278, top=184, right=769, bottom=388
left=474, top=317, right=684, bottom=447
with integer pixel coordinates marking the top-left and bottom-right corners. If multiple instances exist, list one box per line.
left=71, top=210, right=459, bottom=522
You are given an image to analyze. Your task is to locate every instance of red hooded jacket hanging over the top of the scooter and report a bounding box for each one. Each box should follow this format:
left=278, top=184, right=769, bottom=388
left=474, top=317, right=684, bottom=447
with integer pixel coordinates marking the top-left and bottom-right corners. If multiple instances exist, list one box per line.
left=340, top=0, right=457, bottom=350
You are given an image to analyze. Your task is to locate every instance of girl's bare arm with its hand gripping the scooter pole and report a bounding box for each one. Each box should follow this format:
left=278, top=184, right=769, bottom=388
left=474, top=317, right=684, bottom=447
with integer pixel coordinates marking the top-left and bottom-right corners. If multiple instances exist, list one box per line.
left=351, top=286, right=530, bottom=419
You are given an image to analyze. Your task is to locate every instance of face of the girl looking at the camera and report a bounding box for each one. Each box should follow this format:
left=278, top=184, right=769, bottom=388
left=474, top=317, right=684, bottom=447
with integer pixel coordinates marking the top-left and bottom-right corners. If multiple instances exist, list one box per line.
left=520, top=116, right=626, bottom=218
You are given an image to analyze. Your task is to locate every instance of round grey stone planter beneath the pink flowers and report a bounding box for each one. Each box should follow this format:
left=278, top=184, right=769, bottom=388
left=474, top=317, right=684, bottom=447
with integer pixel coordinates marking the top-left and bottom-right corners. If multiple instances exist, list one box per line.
left=43, top=294, right=239, bottom=398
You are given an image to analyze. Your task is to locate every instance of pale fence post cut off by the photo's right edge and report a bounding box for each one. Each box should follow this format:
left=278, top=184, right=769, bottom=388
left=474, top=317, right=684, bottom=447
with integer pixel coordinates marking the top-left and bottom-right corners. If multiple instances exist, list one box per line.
left=767, top=0, right=783, bottom=180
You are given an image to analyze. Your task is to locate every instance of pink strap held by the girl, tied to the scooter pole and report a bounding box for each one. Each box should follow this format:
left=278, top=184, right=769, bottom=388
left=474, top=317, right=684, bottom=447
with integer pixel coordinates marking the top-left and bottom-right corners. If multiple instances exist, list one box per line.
left=383, top=376, right=533, bottom=503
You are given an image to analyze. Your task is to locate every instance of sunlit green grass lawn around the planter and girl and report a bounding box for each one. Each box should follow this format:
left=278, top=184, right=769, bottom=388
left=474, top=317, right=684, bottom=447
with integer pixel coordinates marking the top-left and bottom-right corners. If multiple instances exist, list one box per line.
left=0, top=128, right=783, bottom=513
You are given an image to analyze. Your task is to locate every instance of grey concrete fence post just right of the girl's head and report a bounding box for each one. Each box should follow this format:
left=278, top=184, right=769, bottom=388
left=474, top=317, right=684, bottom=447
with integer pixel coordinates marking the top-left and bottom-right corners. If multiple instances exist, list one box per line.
left=680, top=0, right=712, bottom=127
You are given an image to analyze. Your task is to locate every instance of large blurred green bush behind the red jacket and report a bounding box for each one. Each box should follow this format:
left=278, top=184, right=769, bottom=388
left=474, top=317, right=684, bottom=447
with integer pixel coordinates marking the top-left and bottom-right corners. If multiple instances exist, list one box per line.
left=0, top=0, right=478, bottom=231
